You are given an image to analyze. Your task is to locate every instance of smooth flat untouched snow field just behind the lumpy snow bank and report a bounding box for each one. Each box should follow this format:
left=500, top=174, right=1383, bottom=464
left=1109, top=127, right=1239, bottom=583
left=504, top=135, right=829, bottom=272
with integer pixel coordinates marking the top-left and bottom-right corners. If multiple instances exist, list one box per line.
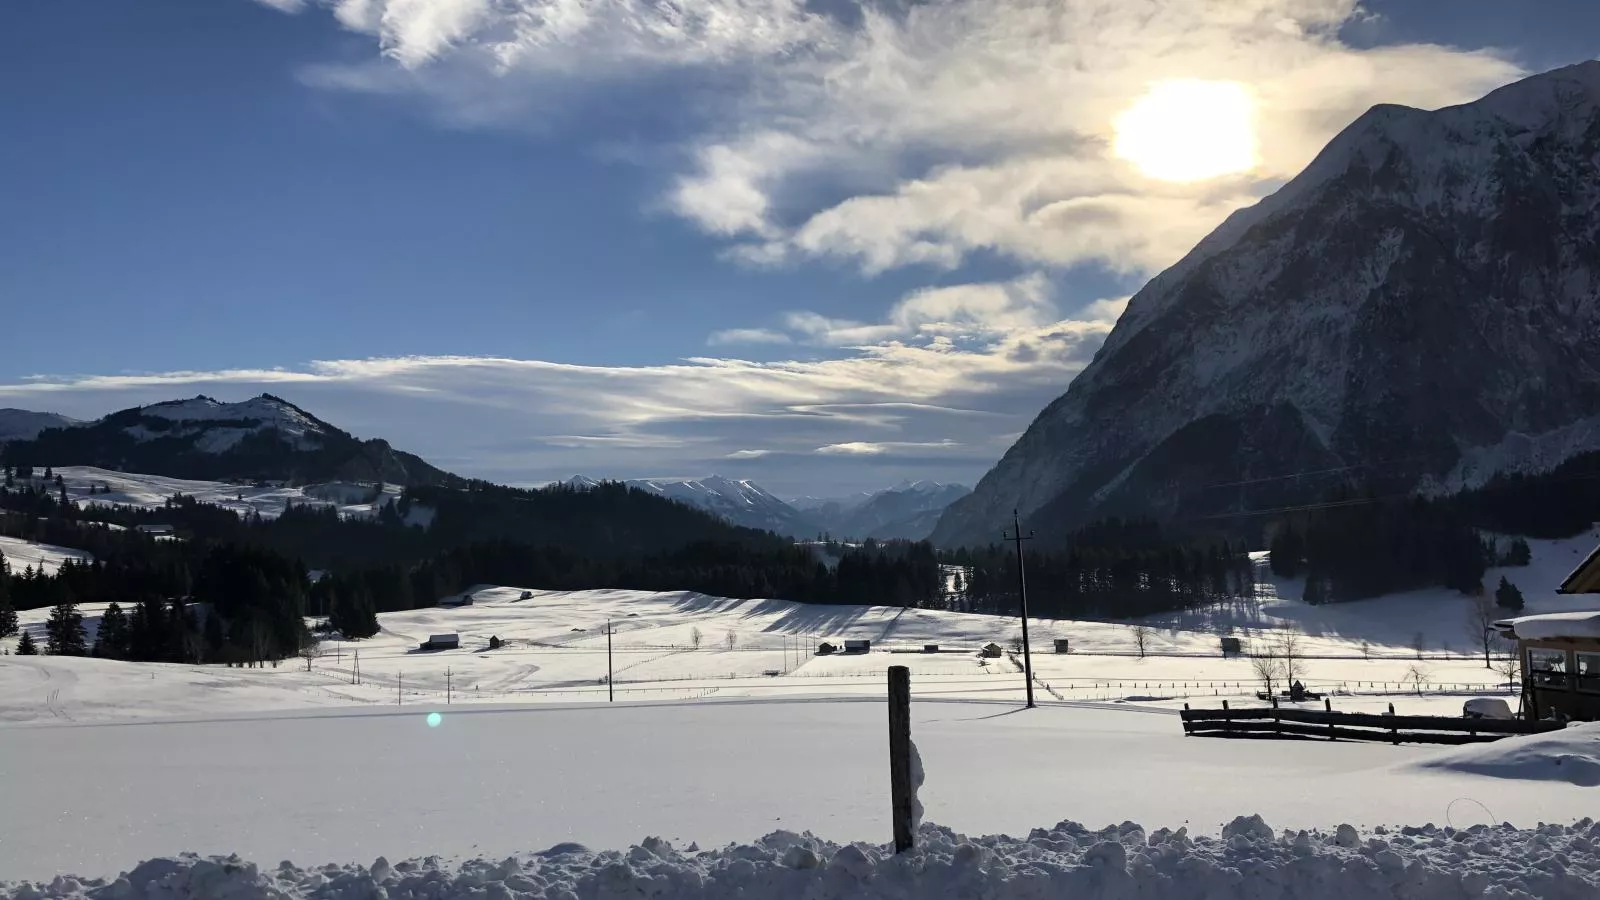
left=0, top=698, right=1594, bottom=879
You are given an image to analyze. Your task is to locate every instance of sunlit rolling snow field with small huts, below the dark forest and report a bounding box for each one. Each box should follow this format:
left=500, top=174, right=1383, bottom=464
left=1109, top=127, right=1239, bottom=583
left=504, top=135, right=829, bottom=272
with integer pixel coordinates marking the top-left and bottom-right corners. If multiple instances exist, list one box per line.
left=12, top=525, right=1600, bottom=722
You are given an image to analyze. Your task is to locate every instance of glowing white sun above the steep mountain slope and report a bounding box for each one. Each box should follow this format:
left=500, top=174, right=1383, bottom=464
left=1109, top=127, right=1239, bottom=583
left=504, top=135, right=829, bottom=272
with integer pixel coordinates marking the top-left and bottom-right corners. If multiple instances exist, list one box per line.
left=1112, top=78, right=1258, bottom=181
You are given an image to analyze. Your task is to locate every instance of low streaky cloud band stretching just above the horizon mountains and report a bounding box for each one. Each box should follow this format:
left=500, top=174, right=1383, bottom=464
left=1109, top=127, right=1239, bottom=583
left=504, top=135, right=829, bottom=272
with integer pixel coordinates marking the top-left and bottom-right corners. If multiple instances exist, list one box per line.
left=0, top=277, right=1120, bottom=493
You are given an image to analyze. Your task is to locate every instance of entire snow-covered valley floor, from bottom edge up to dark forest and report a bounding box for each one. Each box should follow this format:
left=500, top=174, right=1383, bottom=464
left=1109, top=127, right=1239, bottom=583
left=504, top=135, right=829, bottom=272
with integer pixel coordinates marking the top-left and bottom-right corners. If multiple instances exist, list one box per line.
left=0, top=522, right=1600, bottom=883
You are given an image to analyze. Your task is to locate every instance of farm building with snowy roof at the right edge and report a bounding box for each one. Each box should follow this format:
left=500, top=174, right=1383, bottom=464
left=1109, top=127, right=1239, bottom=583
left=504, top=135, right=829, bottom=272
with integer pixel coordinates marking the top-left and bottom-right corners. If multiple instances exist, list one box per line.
left=1494, top=549, right=1600, bottom=722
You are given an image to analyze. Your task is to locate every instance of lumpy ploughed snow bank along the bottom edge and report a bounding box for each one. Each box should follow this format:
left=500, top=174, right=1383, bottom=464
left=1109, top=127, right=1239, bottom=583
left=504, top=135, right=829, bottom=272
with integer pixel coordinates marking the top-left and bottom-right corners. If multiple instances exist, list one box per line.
left=0, top=817, right=1600, bottom=900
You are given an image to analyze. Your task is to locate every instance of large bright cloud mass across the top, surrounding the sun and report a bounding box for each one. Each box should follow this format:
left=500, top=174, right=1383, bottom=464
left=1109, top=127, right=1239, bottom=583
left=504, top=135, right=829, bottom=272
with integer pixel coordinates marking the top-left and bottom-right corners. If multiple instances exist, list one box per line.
left=265, top=0, right=1520, bottom=274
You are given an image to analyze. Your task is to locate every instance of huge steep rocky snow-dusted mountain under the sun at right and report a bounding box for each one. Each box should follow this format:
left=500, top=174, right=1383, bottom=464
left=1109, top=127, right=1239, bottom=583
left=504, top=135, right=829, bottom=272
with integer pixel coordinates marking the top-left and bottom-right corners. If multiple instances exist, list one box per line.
left=934, top=62, right=1600, bottom=544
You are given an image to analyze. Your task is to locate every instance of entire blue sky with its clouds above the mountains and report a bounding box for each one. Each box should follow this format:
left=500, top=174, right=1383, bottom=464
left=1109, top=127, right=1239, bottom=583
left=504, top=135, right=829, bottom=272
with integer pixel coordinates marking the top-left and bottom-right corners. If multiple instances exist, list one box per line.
left=0, top=0, right=1600, bottom=495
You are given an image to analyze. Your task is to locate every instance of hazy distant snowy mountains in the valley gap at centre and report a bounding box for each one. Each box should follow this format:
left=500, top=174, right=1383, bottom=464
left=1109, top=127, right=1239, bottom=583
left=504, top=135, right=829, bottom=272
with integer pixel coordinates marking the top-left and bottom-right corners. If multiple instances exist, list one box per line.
left=563, top=476, right=970, bottom=540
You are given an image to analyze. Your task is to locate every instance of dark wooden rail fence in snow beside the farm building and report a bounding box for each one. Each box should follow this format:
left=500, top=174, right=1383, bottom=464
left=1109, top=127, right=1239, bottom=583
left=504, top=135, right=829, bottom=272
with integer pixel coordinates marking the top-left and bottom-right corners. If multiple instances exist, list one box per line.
left=1182, top=705, right=1565, bottom=745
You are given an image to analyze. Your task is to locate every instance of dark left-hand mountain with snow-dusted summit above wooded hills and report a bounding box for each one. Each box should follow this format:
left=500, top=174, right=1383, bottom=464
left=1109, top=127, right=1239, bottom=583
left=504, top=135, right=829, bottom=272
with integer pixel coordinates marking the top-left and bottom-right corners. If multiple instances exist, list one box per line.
left=0, top=394, right=464, bottom=485
